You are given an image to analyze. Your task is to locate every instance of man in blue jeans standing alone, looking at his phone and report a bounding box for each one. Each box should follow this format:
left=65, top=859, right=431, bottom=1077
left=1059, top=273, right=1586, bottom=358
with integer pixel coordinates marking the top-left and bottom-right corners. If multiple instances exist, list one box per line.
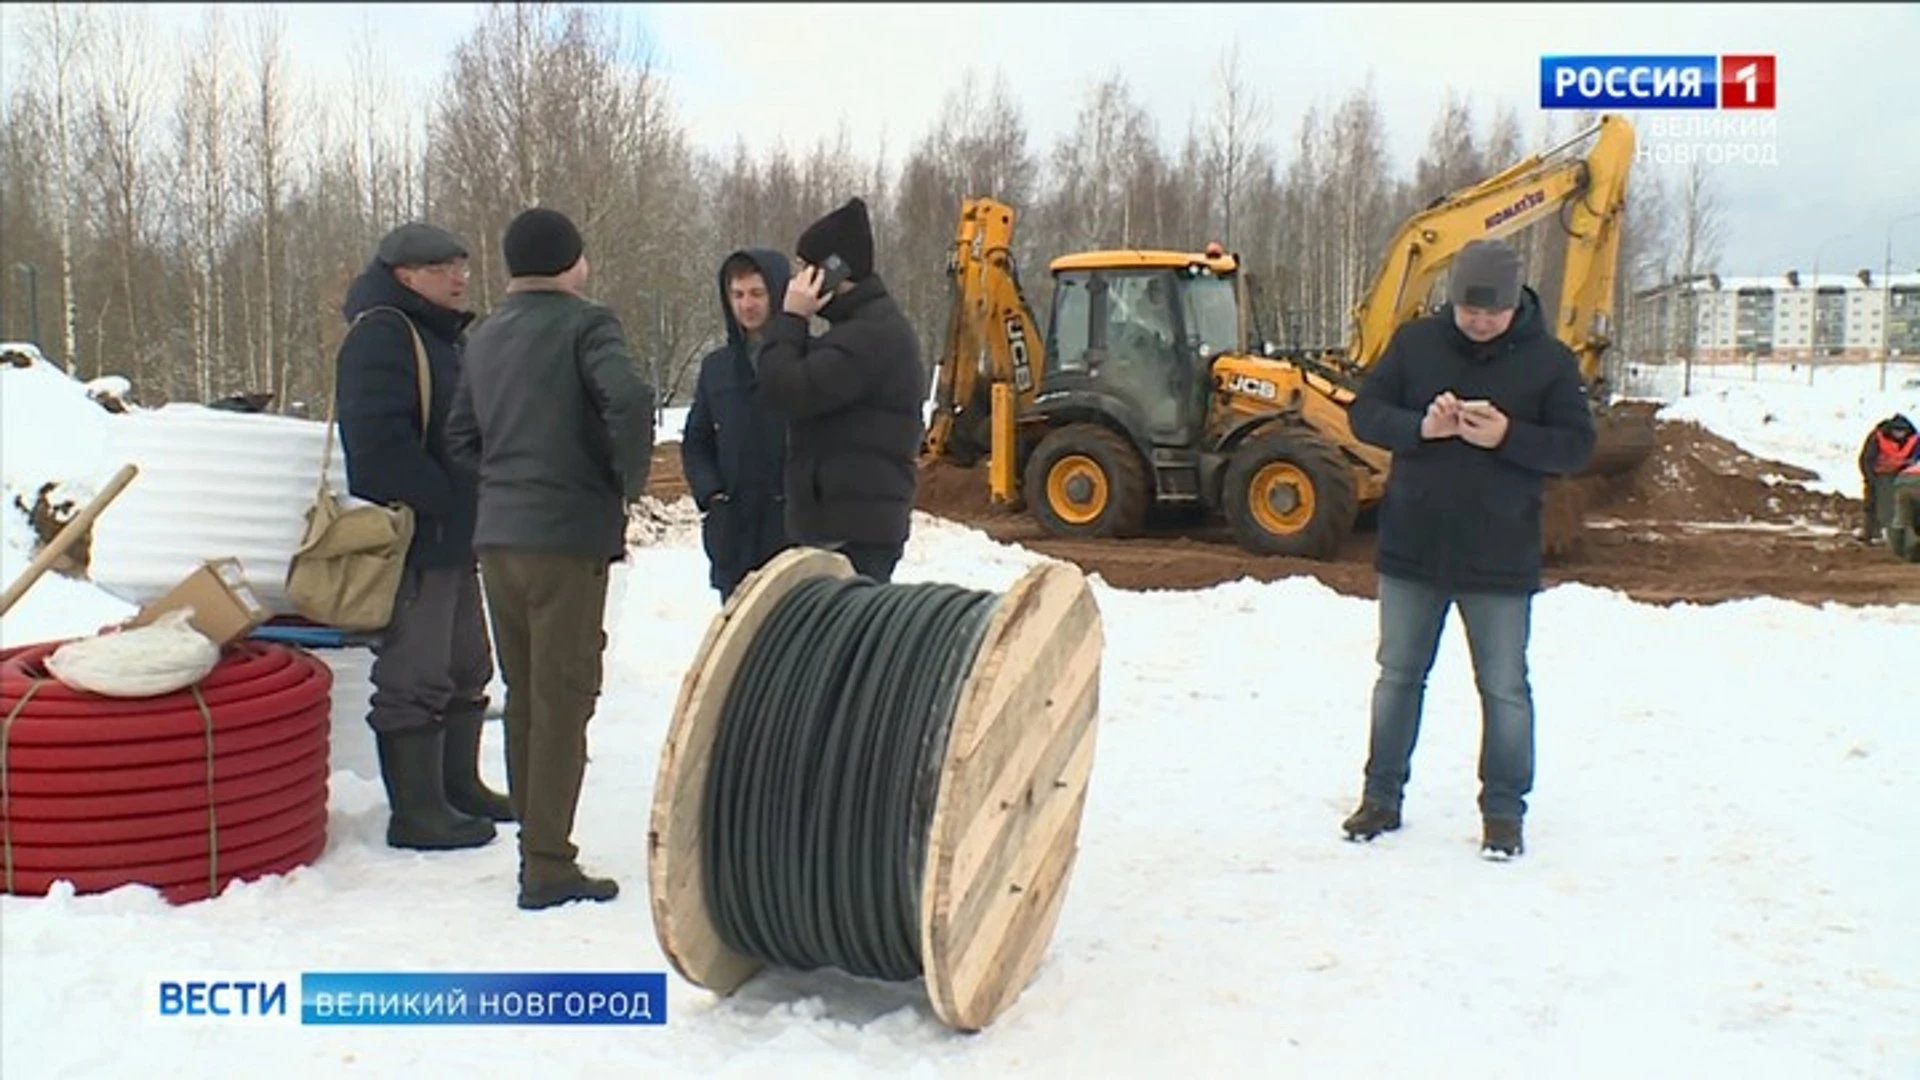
left=1342, top=240, right=1596, bottom=859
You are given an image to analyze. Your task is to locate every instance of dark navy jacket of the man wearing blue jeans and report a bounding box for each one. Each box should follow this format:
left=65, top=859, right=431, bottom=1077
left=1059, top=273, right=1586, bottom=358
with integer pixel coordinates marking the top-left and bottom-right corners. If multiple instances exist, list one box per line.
left=1348, top=288, right=1596, bottom=594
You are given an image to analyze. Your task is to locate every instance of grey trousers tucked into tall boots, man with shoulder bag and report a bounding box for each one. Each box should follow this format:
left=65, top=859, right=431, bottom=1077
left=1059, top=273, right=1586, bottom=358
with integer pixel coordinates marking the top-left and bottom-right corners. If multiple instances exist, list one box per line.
left=367, top=567, right=493, bottom=732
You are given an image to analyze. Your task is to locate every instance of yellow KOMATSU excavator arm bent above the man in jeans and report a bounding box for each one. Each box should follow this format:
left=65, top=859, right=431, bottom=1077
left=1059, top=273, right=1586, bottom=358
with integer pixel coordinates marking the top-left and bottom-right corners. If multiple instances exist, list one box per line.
left=1346, top=115, right=1634, bottom=386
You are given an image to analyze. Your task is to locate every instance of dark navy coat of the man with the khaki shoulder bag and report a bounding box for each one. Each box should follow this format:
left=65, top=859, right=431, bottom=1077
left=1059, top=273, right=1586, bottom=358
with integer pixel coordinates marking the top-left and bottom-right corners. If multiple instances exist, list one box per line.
left=334, top=261, right=476, bottom=567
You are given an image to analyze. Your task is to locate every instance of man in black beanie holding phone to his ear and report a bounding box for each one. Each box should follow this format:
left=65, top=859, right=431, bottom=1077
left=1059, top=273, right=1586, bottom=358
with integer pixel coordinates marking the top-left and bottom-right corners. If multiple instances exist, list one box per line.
left=758, top=198, right=925, bottom=582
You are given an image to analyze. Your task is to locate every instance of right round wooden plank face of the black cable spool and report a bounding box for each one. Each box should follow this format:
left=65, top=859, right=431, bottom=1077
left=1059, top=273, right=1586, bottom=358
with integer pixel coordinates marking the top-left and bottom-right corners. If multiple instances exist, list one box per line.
left=920, top=563, right=1104, bottom=1032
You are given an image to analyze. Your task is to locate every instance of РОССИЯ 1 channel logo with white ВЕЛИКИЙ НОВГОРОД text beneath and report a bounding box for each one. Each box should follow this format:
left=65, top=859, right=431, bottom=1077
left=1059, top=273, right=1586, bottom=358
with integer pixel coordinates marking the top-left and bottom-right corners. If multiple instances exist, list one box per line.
left=1540, top=52, right=1780, bottom=167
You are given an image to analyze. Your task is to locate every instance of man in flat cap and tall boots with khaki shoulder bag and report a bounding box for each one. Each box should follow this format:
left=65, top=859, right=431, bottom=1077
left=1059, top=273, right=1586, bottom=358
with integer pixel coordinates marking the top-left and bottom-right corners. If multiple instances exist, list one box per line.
left=334, top=223, right=513, bottom=849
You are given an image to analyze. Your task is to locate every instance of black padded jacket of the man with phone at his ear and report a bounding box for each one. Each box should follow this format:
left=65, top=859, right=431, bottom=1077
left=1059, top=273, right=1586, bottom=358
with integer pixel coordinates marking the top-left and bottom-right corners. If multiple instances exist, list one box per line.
left=758, top=277, right=925, bottom=544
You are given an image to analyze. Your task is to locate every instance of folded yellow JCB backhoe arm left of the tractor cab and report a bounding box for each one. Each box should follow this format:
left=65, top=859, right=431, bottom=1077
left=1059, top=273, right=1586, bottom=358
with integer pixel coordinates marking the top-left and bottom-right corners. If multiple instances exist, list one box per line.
left=922, top=198, right=1044, bottom=467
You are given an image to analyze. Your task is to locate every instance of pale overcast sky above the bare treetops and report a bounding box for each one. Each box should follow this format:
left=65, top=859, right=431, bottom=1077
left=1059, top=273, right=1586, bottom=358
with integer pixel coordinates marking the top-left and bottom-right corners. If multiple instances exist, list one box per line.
left=0, top=4, right=1920, bottom=275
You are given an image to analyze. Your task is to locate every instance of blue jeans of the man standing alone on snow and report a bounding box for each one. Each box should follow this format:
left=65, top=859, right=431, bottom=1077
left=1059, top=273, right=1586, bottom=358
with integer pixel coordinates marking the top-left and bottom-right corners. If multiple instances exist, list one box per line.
left=1365, top=575, right=1534, bottom=819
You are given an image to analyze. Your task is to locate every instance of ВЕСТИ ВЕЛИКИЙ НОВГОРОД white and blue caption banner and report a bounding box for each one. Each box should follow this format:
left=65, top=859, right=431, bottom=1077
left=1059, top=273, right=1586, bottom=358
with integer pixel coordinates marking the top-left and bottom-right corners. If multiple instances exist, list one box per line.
left=142, top=970, right=666, bottom=1026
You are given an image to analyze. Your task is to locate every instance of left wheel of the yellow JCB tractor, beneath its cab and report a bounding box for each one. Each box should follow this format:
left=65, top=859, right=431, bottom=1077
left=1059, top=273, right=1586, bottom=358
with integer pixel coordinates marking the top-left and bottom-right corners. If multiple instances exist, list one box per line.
left=1021, top=423, right=1152, bottom=538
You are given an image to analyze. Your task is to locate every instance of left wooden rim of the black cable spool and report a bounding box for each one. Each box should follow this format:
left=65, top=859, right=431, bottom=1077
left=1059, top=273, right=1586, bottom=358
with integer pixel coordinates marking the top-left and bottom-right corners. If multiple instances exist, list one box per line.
left=647, top=548, right=852, bottom=994
